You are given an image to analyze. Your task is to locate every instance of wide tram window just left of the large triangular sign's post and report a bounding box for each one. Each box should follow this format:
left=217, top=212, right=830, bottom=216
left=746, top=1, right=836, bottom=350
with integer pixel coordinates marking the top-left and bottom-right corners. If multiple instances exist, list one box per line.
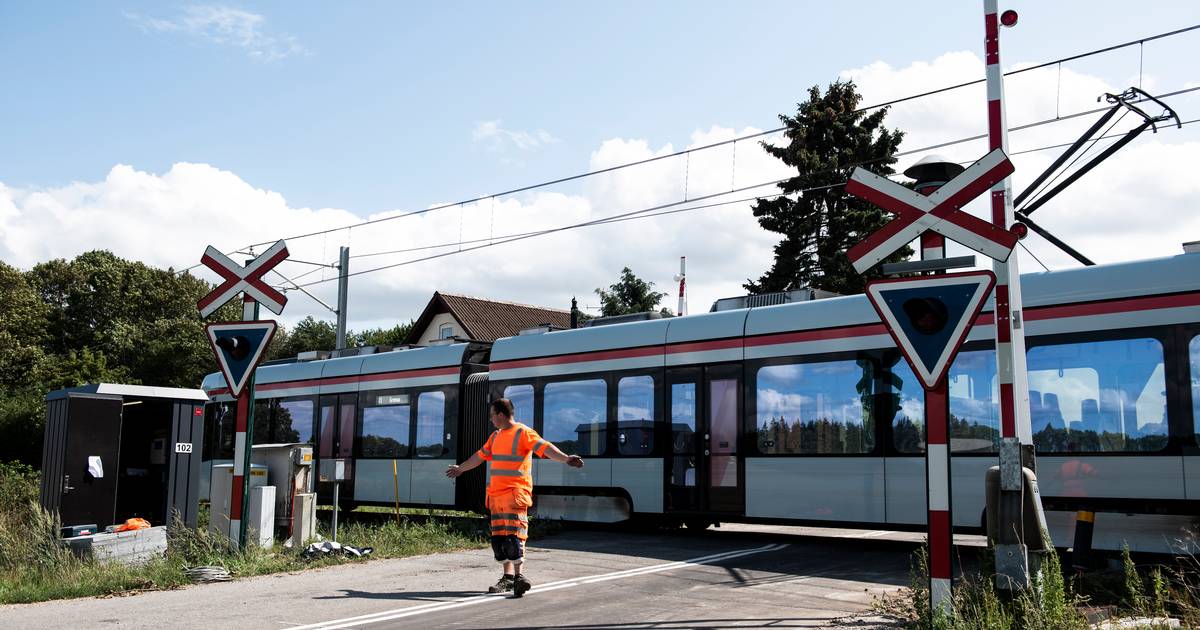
left=756, top=359, right=875, bottom=455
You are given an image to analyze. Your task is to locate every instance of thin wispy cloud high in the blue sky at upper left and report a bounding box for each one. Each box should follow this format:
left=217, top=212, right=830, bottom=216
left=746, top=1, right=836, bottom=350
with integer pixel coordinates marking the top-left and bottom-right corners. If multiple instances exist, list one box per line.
left=126, top=5, right=307, bottom=61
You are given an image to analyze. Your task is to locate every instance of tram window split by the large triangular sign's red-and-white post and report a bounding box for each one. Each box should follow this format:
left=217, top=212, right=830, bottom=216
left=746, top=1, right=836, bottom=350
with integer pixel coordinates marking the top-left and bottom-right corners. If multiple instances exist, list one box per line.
left=889, top=350, right=1000, bottom=452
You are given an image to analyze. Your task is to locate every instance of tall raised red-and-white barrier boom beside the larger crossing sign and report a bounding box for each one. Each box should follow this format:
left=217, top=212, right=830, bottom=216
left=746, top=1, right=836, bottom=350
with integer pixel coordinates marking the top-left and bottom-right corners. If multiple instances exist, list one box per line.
left=983, top=0, right=1040, bottom=588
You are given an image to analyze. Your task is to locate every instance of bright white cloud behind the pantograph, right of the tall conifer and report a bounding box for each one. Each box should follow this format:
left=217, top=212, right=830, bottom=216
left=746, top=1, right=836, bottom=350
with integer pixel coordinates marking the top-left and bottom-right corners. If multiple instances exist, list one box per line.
left=842, top=52, right=1200, bottom=271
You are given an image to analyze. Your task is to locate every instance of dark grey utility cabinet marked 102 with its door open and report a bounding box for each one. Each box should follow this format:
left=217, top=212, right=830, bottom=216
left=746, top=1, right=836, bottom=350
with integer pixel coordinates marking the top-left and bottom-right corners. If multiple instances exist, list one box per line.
left=41, top=383, right=208, bottom=530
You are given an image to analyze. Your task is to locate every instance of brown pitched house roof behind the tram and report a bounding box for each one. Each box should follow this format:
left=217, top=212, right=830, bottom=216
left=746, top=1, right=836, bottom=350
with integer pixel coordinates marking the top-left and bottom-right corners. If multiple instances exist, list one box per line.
left=404, top=292, right=571, bottom=344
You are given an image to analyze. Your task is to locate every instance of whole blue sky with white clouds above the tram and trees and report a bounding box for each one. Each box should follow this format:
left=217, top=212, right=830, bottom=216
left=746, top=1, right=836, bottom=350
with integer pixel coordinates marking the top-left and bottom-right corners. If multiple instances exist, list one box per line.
left=0, top=0, right=1200, bottom=330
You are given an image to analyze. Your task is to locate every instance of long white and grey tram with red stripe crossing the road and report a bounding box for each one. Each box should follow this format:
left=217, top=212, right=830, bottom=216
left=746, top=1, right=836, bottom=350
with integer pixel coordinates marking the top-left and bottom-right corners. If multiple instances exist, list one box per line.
left=204, top=248, right=1200, bottom=552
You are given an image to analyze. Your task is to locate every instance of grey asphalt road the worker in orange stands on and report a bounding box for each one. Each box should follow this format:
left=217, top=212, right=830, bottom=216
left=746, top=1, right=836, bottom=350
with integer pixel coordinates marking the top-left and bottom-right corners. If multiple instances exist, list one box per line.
left=0, top=526, right=984, bottom=630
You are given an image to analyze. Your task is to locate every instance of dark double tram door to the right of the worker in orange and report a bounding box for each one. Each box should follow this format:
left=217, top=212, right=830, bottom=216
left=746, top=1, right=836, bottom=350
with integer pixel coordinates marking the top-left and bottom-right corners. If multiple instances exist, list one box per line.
left=667, top=365, right=745, bottom=514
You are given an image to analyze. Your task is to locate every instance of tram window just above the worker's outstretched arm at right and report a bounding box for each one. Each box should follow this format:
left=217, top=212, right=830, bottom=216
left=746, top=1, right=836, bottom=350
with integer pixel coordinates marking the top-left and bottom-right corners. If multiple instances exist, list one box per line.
left=541, top=379, right=608, bottom=456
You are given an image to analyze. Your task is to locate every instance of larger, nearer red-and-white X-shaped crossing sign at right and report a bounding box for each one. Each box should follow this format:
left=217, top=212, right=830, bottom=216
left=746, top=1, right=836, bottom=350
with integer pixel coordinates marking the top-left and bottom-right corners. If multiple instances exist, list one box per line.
left=846, top=149, right=1016, bottom=274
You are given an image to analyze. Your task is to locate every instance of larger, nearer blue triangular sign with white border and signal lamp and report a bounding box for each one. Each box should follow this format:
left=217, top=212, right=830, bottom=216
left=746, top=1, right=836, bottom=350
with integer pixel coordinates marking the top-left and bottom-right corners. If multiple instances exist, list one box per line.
left=866, top=271, right=996, bottom=389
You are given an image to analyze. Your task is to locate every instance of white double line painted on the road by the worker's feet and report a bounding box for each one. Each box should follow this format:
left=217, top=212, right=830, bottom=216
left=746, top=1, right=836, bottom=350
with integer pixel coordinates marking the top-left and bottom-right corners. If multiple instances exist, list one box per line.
left=288, top=544, right=787, bottom=630
